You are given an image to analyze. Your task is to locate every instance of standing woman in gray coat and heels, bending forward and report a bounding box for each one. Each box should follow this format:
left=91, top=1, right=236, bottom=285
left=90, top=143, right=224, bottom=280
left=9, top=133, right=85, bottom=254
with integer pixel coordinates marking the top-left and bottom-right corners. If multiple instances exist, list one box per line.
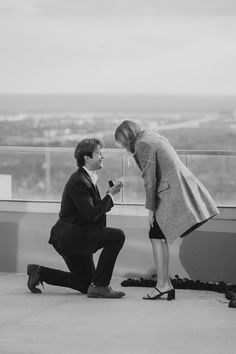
left=115, top=120, right=219, bottom=300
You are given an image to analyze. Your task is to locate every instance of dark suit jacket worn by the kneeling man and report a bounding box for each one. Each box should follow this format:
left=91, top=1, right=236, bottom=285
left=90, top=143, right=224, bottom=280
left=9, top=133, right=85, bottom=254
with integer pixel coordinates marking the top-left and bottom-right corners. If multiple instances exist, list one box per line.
left=49, top=167, right=114, bottom=255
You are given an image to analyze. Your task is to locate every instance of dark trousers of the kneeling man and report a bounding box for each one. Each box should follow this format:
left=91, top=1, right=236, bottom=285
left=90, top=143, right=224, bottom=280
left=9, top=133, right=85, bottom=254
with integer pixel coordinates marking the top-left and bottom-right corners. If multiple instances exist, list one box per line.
left=40, top=227, right=125, bottom=293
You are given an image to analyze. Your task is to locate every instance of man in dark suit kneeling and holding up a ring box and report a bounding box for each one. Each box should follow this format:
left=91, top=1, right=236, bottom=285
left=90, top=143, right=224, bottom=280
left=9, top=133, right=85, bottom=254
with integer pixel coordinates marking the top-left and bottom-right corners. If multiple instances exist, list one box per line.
left=27, top=138, right=125, bottom=298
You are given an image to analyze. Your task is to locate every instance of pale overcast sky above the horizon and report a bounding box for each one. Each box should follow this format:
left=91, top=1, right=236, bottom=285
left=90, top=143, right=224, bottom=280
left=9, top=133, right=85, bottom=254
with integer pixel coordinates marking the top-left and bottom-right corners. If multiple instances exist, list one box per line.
left=0, top=0, right=236, bottom=95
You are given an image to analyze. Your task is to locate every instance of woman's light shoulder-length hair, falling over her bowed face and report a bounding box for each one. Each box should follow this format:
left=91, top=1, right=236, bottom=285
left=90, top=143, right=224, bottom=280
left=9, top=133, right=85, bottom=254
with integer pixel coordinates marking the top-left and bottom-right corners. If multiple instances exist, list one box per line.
left=115, top=120, right=141, bottom=153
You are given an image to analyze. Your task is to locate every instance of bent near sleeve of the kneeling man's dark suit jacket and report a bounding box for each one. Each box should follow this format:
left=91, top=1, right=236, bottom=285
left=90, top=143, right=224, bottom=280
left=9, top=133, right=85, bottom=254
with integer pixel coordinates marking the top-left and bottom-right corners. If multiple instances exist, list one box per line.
left=70, top=182, right=114, bottom=223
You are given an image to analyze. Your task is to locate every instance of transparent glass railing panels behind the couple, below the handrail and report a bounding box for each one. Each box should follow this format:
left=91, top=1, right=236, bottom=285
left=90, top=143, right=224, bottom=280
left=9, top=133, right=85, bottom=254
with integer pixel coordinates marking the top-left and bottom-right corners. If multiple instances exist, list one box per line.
left=0, top=146, right=236, bottom=206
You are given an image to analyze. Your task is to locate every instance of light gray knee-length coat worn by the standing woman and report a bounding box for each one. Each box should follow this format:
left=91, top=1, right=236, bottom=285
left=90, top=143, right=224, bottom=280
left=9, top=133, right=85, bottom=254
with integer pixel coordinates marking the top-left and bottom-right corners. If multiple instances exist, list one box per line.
left=133, top=130, right=219, bottom=243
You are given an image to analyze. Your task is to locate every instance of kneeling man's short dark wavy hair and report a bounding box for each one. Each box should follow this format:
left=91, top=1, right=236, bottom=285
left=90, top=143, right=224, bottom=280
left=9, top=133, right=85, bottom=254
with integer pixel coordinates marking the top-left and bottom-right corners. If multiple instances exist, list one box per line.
left=74, top=138, right=103, bottom=167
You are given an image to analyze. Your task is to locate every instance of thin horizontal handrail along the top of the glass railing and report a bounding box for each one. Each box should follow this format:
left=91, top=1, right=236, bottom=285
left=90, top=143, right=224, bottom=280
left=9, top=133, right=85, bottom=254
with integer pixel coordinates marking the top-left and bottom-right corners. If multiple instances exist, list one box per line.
left=0, top=146, right=236, bottom=156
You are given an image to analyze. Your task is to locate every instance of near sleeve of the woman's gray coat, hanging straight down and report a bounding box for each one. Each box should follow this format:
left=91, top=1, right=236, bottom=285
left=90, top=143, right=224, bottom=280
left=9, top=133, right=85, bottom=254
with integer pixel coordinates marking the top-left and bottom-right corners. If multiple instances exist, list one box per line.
left=136, top=142, right=160, bottom=210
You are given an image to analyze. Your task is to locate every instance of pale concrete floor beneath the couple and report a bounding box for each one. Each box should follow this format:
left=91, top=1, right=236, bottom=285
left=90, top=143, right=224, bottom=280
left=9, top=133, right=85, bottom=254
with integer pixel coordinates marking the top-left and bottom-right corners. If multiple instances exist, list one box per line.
left=0, top=273, right=236, bottom=354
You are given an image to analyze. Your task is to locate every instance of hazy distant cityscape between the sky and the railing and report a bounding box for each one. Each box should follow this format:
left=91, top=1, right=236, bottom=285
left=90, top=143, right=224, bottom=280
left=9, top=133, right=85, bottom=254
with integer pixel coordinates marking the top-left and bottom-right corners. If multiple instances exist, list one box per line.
left=0, top=95, right=236, bottom=150
